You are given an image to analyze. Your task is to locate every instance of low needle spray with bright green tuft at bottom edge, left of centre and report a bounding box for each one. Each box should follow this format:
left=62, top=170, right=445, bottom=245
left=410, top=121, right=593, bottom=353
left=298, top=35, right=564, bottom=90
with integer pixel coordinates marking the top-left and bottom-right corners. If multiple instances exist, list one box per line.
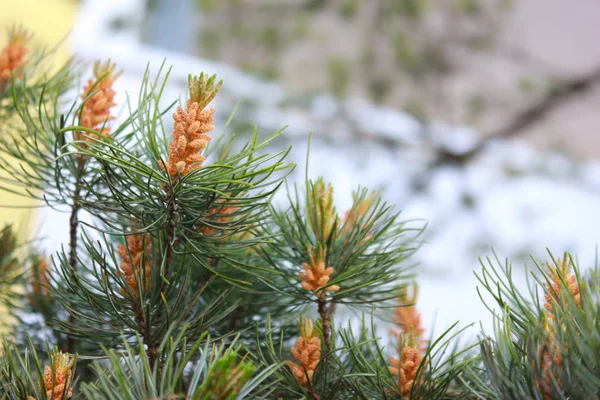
left=82, top=329, right=277, bottom=400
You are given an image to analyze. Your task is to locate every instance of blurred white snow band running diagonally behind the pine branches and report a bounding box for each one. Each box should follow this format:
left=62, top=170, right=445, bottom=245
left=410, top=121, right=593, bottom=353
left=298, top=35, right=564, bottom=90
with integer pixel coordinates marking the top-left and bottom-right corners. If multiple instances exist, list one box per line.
left=35, top=0, right=600, bottom=340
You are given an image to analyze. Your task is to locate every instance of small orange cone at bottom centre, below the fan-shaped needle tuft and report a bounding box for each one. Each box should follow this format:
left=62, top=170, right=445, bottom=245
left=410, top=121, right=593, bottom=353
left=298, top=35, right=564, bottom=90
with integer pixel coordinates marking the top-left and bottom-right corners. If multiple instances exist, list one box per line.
left=287, top=319, right=321, bottom=387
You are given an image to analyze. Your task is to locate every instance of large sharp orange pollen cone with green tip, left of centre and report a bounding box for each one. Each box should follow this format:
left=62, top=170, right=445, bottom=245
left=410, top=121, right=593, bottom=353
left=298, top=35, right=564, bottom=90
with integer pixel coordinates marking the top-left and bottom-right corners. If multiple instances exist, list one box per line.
left=161, top=74, right=222, bottom=180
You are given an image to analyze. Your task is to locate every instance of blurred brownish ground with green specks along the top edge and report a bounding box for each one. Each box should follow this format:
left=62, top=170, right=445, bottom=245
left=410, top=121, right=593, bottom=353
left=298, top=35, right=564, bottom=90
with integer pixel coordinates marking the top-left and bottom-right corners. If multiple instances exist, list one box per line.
left=184, top=0, right=509, bottom=108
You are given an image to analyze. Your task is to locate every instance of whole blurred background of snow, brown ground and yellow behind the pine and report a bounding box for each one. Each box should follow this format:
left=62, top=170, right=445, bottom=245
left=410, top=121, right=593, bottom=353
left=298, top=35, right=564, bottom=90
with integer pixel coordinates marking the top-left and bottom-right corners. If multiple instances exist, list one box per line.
left=0, top=0, right=600, bottom=329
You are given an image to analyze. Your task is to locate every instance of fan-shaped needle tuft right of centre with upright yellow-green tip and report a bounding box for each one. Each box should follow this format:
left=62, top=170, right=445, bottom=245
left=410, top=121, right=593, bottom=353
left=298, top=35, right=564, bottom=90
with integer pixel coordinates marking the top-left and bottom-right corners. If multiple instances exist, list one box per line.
left=264, top=179, right=419, bottom=307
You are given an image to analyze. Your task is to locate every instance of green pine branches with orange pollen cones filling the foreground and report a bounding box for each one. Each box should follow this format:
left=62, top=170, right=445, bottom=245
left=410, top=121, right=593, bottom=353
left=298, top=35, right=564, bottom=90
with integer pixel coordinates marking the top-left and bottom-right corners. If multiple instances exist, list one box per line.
left=0, top=25, right=600, bottom=400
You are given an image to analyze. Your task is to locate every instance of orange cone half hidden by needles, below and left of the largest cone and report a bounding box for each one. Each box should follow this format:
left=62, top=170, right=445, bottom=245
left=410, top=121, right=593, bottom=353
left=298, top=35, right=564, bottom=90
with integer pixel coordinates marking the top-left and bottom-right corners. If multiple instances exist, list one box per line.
left=117, top=228, right=152, bottom=300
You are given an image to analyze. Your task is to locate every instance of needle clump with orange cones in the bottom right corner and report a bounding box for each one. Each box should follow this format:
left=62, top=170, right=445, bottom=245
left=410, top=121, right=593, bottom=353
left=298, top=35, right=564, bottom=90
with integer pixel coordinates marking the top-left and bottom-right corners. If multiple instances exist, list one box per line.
left=473, top=254, right=600, bottom=399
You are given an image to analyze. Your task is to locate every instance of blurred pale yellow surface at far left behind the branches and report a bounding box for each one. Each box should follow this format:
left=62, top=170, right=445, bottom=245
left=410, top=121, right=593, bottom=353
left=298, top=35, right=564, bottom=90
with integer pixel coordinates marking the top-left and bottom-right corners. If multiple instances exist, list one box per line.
left=0, top=0, right=79, bottom=332
